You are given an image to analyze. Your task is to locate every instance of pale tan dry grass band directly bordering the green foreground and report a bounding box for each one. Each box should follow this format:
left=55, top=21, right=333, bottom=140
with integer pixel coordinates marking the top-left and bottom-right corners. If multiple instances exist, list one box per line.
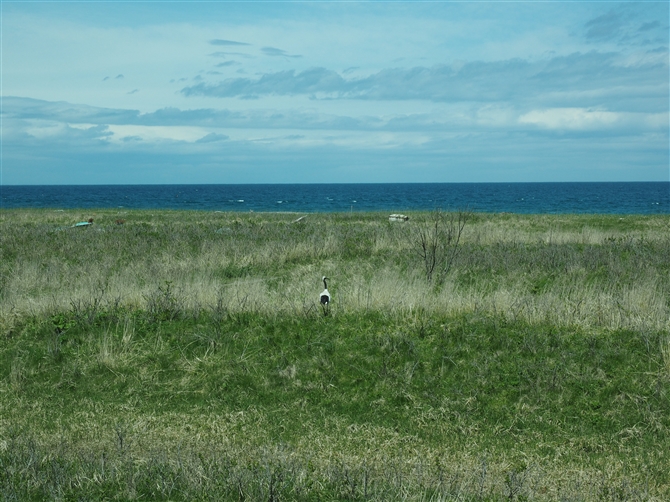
left=0, top=265, right=670, bottom=338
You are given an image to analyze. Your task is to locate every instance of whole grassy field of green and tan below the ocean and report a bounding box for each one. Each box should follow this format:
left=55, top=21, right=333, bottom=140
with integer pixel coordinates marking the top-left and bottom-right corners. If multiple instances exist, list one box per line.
left=0, top=210, right=670, bottom=501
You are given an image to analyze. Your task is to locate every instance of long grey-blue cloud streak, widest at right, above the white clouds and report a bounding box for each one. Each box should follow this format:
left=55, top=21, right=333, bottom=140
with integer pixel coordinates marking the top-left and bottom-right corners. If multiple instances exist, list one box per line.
left=181, top=50, right=668, bottom=111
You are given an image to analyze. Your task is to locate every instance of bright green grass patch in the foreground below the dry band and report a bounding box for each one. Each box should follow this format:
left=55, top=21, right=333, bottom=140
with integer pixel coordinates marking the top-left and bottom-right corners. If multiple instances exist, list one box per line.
left=0, top=311, right=670, bottom=500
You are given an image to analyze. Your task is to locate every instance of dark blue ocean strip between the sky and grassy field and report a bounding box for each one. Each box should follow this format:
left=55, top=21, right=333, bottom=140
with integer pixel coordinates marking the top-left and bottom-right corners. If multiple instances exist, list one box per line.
left=0, top=182, right=670, bottom=214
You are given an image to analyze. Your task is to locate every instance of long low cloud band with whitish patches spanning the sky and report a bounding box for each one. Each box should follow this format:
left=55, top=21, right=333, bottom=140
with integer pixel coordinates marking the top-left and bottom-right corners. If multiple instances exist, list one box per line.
left=4, top=92, right=668, bottom=147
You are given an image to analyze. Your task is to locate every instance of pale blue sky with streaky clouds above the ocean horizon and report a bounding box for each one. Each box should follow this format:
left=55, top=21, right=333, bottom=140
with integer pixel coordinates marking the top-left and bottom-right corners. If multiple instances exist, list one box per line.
left=0, top=0, right=670, bottom=185
